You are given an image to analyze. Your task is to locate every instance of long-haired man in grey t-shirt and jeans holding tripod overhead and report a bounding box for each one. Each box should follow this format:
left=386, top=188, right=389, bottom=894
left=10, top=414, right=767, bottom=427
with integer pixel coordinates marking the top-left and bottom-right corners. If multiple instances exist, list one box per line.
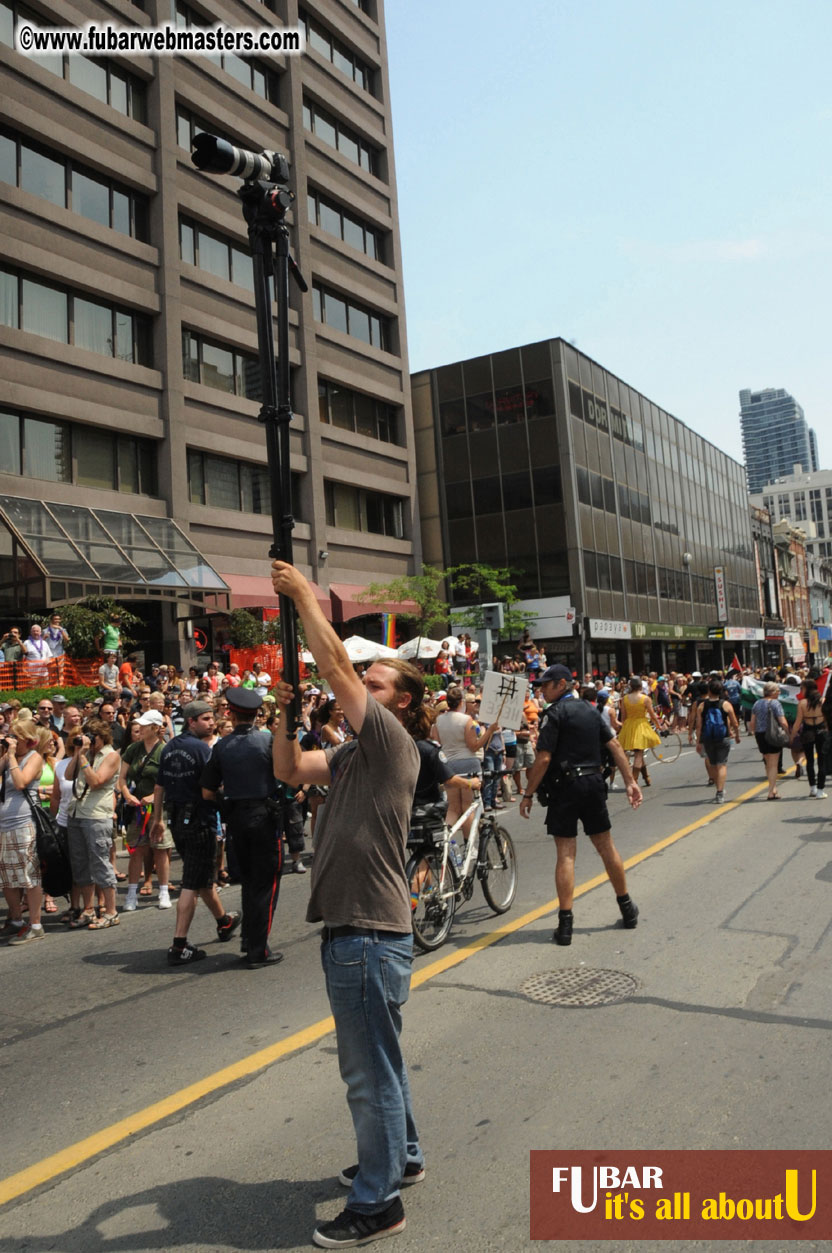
left=272, top=561, right=425, bottom=1248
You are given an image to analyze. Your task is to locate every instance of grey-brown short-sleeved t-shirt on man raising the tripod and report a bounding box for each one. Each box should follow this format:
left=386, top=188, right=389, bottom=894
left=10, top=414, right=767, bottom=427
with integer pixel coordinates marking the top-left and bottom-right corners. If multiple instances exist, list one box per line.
left=306, top=694, right=420, bottom=933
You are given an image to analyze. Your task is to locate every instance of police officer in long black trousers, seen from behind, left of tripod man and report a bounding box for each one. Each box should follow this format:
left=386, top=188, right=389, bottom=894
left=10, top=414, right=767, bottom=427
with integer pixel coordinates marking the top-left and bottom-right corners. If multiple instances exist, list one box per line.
left=202, top=688, right=283, bottom=970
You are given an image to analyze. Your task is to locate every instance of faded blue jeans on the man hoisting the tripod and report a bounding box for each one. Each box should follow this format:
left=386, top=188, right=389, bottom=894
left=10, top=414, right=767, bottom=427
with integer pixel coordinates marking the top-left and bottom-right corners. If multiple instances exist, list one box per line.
left=321, top=931, right=424, bottom=1214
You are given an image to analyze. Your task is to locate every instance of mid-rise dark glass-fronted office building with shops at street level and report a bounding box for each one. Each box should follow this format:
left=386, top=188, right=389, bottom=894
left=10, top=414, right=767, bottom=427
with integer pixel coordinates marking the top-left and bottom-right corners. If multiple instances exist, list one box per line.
left=411, top=340, right=763, bottom=673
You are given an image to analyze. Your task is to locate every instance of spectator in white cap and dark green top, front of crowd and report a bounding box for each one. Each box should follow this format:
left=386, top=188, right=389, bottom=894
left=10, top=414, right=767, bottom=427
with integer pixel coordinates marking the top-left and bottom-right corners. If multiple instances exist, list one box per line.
left=118, top=709, right=173, bottom=912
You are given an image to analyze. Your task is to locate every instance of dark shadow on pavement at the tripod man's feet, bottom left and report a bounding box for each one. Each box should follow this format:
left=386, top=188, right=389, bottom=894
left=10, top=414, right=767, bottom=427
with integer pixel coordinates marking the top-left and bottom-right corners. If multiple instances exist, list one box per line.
left=0, top=1177, right=347, bottom=1253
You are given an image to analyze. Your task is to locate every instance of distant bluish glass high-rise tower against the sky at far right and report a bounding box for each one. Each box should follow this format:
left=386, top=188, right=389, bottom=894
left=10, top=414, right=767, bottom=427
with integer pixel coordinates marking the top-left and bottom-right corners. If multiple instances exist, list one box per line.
left=739, top=387, right=818, bottom=494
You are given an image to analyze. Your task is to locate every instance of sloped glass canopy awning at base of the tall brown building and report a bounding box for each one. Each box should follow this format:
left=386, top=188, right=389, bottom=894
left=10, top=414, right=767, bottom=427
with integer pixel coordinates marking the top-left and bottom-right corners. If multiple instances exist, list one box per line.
left=0, top=495, right=229, bottom=609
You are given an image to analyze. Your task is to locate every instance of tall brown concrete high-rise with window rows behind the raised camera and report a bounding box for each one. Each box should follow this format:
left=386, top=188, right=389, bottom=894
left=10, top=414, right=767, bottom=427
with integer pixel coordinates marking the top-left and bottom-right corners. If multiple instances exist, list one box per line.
left=0, top=0, right=420, bottom=658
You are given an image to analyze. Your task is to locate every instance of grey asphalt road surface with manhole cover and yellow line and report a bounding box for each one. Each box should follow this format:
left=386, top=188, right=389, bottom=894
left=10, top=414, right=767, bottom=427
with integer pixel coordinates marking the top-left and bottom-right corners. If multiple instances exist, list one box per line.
left=0, top=739, right=832, bottom=1253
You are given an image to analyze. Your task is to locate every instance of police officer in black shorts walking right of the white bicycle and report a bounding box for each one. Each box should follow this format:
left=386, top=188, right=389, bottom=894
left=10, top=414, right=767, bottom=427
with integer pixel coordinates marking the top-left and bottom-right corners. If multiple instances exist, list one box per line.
left=520, top=665, right=643, bottom=945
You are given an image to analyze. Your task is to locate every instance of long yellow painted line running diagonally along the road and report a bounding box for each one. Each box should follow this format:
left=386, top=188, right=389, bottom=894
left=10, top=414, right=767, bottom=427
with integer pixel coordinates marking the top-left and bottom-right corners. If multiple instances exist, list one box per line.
left=0, top=766, right=781, bottom=1205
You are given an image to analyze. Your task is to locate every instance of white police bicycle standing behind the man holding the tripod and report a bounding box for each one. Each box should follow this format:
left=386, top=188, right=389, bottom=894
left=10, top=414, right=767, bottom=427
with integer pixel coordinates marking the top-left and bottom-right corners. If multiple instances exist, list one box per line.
left=406, top=771, right=517, bottom=952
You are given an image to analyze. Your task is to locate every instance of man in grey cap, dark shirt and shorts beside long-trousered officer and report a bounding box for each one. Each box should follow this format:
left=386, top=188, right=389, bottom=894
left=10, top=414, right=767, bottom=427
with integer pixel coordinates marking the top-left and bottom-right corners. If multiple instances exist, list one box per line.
left=150, top=700, right=241, bottom=966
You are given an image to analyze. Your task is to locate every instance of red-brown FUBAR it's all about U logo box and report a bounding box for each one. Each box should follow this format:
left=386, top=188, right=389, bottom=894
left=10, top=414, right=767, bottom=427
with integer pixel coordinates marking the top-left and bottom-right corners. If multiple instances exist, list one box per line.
left=530, top=1149, right=832, bottom=1244
